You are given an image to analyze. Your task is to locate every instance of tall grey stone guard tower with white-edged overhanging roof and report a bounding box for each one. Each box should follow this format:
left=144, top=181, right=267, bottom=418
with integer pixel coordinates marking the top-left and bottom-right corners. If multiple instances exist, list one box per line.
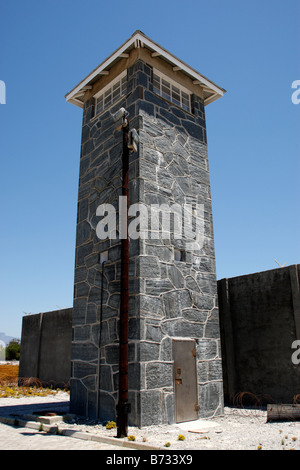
left=66, top=31, right=225, bottom=426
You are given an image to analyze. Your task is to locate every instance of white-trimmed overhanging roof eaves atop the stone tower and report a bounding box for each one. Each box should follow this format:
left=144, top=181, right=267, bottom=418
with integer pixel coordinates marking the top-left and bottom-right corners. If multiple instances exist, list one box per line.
left=65, top=31, right=226, bottom=108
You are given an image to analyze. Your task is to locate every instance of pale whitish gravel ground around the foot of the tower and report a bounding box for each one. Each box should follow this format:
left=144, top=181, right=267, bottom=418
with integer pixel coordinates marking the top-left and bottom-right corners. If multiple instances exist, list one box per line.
left=59, top=407, right=300, bottom=451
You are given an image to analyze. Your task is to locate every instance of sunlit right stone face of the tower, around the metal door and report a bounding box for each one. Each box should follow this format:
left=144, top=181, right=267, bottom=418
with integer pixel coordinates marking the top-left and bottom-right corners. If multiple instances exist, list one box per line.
left=136, top=63, right=222, bottom=425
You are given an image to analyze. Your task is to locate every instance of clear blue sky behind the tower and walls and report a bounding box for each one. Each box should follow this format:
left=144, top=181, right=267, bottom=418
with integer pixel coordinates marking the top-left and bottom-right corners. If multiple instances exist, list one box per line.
left=0, top=0, right=300, bottom=337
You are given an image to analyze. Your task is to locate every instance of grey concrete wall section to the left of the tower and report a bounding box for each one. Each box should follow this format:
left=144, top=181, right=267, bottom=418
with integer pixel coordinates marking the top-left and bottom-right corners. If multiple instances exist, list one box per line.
left=19, top=308, right=72, bottom=388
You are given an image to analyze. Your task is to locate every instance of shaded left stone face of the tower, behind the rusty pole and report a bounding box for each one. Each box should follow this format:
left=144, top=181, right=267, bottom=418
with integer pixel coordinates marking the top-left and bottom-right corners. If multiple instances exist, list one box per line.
left=70, top=63, right=144, bottom=422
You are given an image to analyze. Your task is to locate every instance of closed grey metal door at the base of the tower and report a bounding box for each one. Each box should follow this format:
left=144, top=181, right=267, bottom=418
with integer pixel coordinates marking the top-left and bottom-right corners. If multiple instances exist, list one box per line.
left=173, top=340, right=199, bottom=423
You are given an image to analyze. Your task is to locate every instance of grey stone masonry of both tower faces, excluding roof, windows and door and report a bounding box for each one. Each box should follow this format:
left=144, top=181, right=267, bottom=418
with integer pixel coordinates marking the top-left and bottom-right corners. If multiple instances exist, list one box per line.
left=71, top=61, right=223, bottom=426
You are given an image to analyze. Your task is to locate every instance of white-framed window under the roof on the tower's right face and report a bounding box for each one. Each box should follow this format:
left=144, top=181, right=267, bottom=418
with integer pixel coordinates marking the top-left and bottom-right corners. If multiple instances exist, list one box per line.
left=153, top=70, right=191, bottom=113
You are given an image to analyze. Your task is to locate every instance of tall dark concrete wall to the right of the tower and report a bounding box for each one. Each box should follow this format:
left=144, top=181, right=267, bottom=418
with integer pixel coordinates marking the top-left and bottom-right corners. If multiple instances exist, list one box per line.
left=218, top=265, right=300, bottom=403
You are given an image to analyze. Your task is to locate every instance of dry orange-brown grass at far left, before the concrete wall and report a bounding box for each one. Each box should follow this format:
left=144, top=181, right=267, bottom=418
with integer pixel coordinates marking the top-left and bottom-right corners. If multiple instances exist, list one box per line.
left=0, top=364, right=68, bottom=398
